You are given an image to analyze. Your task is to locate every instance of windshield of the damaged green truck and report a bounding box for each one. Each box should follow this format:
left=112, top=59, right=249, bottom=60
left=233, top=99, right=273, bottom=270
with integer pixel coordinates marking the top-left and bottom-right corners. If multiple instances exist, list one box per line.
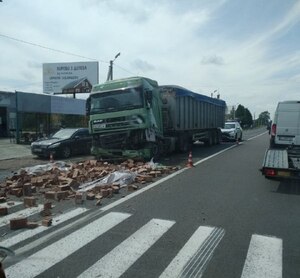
left=90, top=88, right=143, bottom=114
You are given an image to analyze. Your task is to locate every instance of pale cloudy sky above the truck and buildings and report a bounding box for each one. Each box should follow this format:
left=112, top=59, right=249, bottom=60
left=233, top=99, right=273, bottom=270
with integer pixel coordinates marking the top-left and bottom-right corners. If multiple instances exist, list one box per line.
left=0, top=0, right=300, bottom=118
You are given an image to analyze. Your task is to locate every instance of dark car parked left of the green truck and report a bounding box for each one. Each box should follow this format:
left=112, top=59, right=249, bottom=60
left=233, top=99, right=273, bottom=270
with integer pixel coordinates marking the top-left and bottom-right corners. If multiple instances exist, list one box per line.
left=31, top=128, right=92, bottom=158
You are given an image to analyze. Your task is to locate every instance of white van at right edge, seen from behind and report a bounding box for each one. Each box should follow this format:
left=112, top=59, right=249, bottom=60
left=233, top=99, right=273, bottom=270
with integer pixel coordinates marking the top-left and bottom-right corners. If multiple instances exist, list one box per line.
left=270, top=101, right=300, bottom=148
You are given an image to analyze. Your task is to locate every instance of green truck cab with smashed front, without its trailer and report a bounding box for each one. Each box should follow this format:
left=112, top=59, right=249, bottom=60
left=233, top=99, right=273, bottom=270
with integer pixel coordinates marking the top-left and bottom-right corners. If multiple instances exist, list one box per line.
left=87, top=77, right=163, bottom=159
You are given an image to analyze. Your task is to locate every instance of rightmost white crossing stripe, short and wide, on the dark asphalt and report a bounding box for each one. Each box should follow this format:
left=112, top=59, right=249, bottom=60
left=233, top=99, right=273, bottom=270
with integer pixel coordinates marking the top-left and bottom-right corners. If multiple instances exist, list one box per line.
left=241, top=235, right=282, bottom=278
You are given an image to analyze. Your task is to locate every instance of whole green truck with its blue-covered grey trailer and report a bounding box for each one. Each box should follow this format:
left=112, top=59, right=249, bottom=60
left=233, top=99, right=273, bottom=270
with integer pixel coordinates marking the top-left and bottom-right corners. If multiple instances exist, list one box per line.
left=87, top=77, right=226, bottom=159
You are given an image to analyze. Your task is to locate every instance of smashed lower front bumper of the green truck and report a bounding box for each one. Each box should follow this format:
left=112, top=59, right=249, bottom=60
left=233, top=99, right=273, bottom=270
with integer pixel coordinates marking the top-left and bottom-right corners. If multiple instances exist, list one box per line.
left=91, top=147, right=151, bottom=160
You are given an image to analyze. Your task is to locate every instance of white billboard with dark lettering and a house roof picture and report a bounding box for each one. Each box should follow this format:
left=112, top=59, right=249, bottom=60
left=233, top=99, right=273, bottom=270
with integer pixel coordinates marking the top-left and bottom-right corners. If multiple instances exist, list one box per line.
left=43, top=62, right=99, bottom=94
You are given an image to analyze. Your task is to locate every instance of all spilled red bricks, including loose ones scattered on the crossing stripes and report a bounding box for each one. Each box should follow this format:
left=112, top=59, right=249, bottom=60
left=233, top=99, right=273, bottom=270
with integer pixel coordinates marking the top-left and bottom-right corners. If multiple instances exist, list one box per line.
left=0, top=160, right=177, bottom=230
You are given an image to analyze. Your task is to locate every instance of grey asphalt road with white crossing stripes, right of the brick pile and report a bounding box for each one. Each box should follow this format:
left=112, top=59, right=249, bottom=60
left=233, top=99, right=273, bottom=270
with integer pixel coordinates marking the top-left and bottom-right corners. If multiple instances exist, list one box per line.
left=0, top=127, right=300, bottom=278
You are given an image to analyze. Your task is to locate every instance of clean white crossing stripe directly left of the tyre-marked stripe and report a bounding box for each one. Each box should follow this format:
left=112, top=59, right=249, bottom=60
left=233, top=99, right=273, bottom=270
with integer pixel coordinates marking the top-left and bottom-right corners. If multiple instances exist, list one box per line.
left=79, top=219, right=175, bottom=278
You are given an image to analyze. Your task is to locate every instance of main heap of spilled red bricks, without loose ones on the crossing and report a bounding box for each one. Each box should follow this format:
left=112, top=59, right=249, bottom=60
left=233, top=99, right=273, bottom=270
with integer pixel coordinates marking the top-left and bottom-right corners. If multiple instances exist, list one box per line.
left=0, top=159, right=177, bottom=204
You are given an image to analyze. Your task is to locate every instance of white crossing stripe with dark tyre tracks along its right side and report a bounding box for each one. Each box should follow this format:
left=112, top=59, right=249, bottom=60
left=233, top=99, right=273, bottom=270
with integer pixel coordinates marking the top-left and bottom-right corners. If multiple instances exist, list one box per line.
left=160, top=226, right=225, bottom=278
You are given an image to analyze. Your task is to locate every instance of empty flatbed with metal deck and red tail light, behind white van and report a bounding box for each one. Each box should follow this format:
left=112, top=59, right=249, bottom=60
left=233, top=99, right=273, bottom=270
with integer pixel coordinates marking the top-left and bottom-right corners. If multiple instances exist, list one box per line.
left=260, top=149, right=300, bottom=179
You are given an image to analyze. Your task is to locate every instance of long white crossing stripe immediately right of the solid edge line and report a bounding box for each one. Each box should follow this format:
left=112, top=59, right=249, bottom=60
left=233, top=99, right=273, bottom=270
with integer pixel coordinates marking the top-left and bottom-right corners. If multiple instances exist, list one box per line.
left=5, top=212, right=131, bottom=278
